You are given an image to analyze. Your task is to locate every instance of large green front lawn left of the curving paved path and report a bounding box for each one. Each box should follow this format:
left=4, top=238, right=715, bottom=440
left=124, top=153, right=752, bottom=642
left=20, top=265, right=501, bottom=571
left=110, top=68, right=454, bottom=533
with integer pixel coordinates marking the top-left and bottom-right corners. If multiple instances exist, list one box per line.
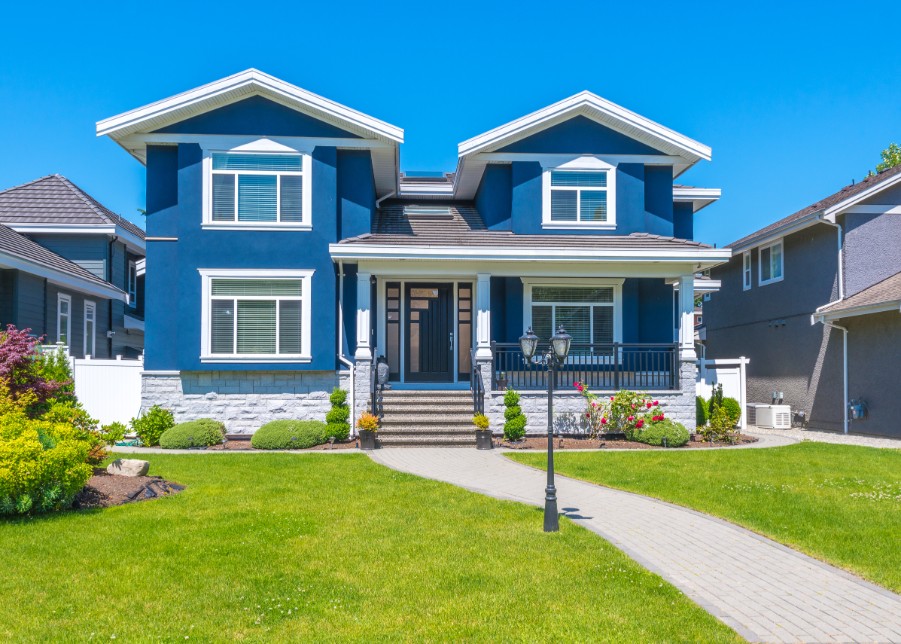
left=0, top=454, right=739, bottom=642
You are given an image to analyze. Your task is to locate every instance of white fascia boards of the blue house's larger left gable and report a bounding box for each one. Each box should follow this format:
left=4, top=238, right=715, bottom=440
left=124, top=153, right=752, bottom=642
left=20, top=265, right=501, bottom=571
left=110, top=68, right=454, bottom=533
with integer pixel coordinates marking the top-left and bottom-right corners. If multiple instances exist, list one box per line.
left=97, top=69, right=404, bottom=143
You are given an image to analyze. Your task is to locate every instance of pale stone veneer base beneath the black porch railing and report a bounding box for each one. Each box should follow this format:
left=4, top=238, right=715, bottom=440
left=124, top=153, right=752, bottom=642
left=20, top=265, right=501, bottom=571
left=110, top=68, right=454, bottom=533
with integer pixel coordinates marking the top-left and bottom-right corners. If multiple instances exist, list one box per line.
left=485, top=361, right=697, bottom=435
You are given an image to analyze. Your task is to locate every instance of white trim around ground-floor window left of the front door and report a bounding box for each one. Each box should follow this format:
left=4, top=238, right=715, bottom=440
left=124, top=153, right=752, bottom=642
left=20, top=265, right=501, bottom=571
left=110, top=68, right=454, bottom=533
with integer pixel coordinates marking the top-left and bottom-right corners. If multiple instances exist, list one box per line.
left=198, top=268, right=315, bottom=364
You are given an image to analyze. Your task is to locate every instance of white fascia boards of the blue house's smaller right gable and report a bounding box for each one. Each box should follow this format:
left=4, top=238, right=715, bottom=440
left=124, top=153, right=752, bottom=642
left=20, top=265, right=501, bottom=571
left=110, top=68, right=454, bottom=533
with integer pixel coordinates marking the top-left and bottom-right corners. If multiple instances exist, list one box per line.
left=457, top=91, right=711, bottom=162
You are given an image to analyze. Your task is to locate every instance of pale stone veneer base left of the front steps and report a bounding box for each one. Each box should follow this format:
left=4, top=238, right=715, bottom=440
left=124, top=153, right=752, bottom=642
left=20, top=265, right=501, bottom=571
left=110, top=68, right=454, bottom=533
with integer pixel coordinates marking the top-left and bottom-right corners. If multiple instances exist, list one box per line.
left=141, top=371, right=350, bottom=434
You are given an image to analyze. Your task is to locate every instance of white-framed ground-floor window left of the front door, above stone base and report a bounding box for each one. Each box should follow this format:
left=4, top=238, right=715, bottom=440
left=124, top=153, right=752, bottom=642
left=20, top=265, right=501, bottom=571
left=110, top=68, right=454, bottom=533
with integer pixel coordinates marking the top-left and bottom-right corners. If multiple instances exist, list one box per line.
left=200, top=269, right=313, bottom=362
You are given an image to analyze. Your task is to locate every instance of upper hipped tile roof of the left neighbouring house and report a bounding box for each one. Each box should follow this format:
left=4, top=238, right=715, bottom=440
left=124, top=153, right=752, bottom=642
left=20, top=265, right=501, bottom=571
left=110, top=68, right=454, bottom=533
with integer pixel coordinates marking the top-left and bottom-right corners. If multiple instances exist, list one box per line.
left=0, top=174, right=144, bottom=248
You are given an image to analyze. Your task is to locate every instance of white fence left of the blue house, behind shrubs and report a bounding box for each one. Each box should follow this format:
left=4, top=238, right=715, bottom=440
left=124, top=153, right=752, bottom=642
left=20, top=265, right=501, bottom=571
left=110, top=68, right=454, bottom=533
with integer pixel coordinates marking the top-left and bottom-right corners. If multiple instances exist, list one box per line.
left=72, top=358, right=144, bottom=425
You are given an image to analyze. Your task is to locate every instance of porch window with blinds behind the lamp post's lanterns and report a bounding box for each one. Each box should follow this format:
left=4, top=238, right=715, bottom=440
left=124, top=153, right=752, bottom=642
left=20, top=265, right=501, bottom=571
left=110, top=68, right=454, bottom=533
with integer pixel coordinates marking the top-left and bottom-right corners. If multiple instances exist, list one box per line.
left=532, top=286, right=614, bottom=344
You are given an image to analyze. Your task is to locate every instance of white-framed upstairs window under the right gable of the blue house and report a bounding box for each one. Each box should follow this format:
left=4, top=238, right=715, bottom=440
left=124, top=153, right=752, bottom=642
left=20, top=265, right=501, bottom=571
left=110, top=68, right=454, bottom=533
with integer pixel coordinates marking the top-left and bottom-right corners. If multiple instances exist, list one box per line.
left=542, top=157, right=616, bottom=230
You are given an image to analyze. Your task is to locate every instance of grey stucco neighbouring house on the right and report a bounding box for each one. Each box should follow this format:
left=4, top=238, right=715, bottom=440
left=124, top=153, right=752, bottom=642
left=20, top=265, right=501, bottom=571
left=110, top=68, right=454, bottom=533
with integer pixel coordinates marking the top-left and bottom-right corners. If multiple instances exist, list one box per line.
left=704, top=166, right=901, bottom=437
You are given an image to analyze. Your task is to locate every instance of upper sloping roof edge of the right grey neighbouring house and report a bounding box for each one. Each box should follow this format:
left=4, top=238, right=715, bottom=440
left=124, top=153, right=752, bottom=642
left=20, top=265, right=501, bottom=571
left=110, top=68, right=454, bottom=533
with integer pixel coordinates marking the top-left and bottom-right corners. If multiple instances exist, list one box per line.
left=729, top=165, right=901, bottom=253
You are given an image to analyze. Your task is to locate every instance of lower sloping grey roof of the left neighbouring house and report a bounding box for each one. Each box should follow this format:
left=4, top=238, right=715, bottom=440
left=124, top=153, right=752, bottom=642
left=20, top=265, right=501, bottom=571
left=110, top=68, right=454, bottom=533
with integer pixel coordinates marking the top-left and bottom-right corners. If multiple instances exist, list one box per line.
left=0, top=224, right=128, bottom=302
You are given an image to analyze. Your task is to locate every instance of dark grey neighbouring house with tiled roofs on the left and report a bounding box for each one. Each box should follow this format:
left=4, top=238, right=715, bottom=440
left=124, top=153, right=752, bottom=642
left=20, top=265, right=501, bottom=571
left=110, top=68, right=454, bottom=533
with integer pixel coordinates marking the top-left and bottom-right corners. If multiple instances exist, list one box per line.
left=0, top=175, right=144, bottom=358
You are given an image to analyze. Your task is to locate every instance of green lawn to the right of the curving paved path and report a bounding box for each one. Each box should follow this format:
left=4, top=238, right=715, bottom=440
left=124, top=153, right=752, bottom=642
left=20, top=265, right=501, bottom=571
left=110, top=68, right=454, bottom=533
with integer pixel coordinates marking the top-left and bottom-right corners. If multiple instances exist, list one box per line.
left=510, top=442, right=901, bottom=592
